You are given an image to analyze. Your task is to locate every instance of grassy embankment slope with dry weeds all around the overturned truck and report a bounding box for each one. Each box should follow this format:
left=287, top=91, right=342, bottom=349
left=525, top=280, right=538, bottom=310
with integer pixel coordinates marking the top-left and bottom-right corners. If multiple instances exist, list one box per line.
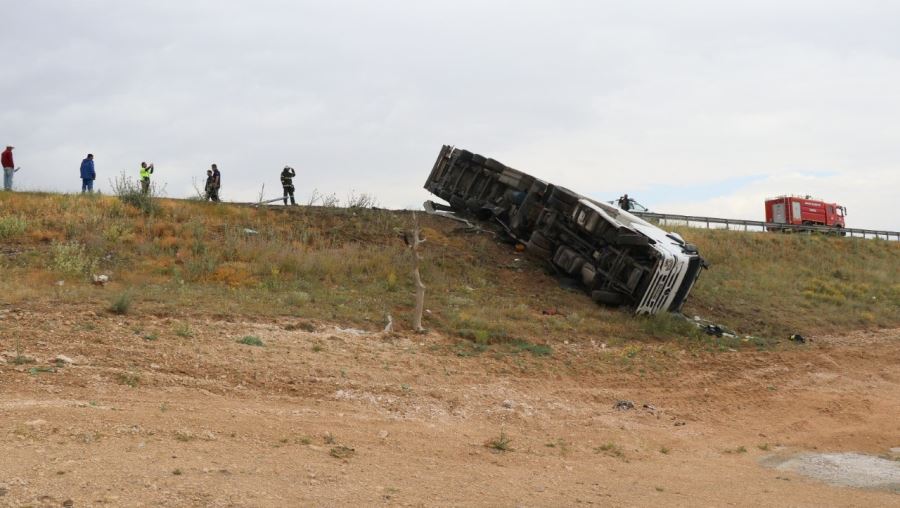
left=0, top=189, right=900, bottom=350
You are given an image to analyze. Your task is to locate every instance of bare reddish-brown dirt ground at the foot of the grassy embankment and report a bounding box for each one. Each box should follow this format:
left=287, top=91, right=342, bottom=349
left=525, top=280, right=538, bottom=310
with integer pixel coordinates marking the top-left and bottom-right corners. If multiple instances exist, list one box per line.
left=0, top=307, right=900, bottom=506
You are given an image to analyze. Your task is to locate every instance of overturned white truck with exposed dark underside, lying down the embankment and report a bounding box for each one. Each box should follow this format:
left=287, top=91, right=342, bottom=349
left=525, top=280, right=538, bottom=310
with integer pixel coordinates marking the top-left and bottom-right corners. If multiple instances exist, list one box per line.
left=425, top=145, right=706, bottom=314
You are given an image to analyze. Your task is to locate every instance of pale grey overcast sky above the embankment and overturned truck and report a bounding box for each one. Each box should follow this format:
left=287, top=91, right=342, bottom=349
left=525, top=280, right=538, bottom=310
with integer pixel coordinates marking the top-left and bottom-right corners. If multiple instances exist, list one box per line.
left=0, top=0, right=900, bottom=230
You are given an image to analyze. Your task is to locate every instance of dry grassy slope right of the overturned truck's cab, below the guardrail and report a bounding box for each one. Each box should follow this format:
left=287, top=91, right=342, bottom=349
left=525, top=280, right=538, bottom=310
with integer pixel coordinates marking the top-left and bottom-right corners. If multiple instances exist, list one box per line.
left=679, top=229, right=900, bottom=336
